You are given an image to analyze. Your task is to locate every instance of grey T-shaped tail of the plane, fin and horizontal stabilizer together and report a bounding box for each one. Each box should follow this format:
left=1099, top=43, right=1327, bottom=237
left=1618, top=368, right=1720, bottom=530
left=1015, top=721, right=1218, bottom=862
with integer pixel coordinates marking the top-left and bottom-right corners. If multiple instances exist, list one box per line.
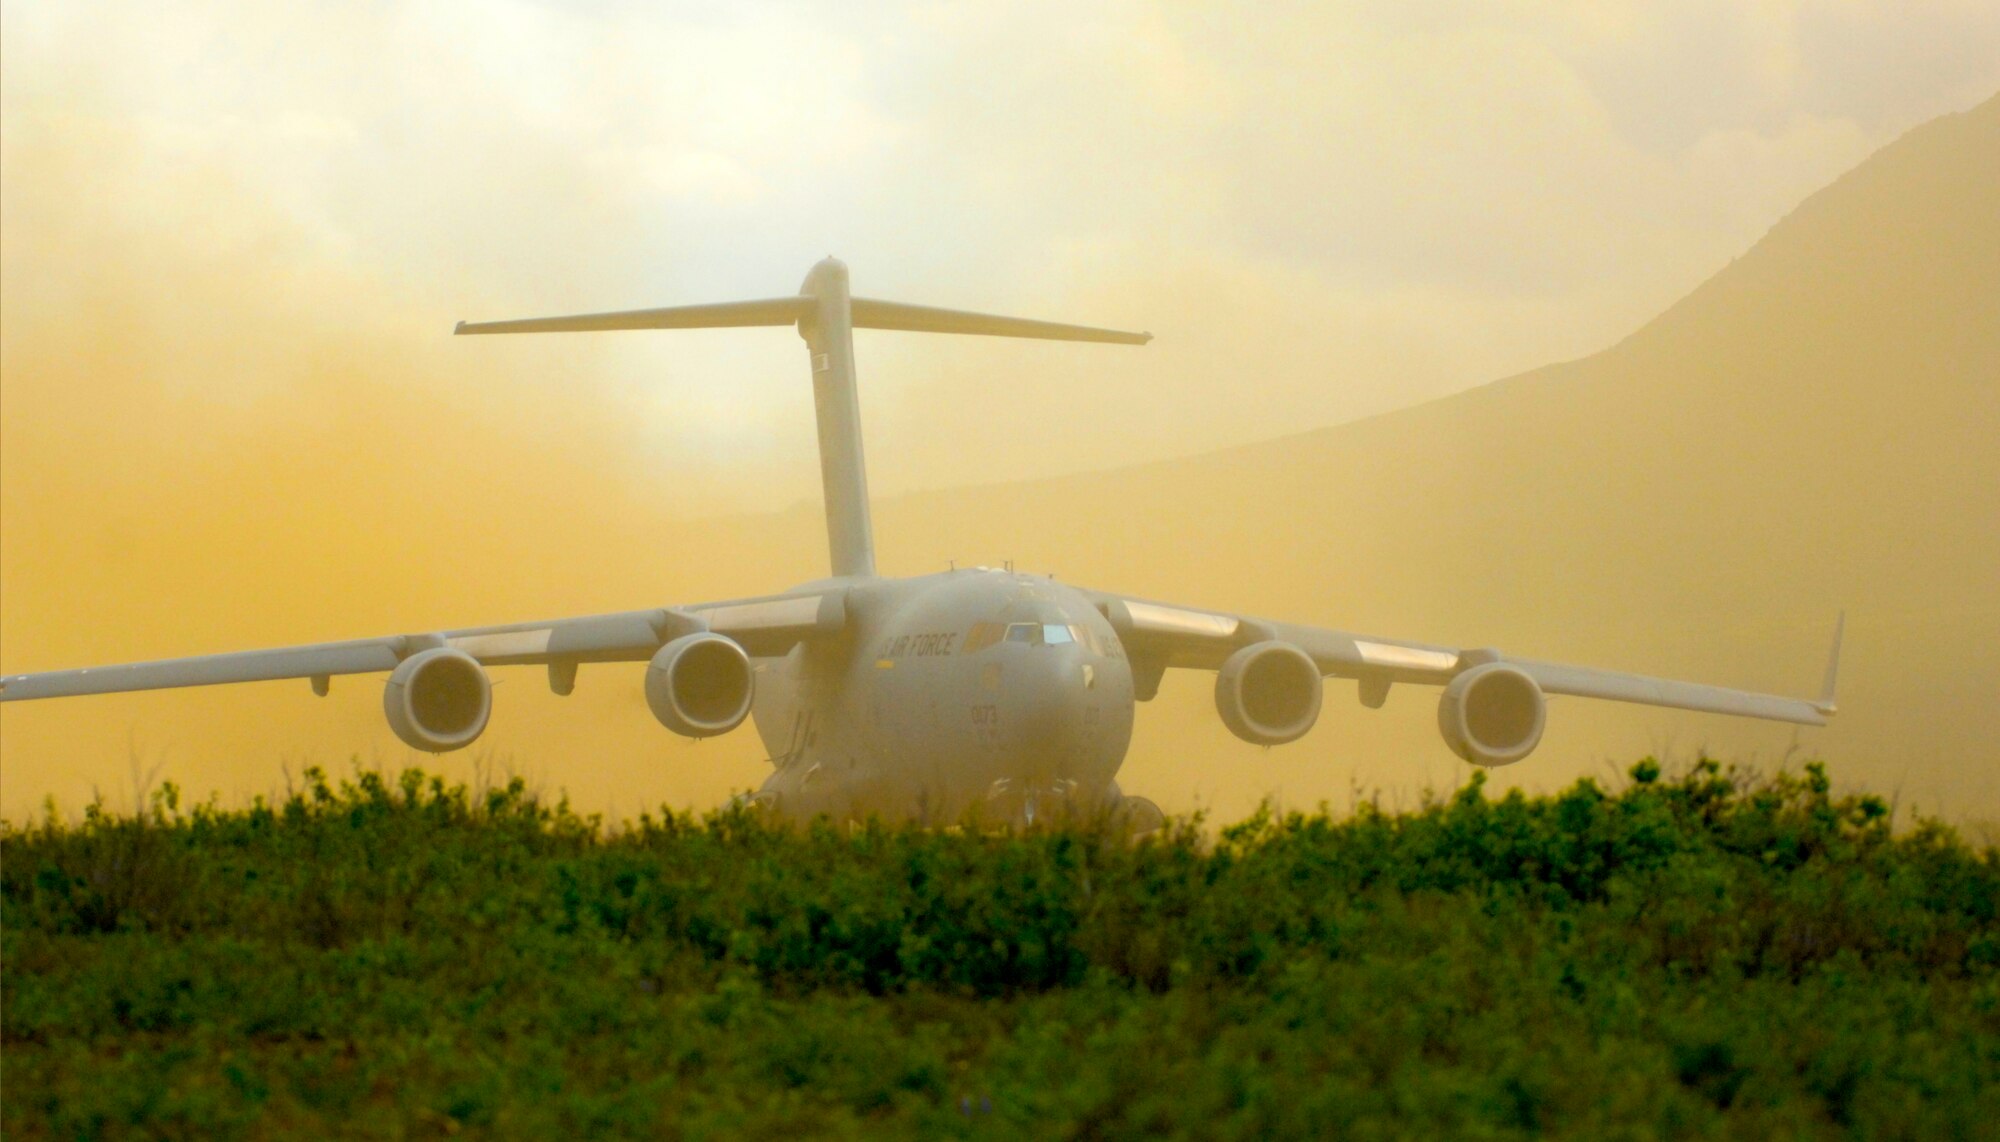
left=456, top=258, right=1152, bottom=576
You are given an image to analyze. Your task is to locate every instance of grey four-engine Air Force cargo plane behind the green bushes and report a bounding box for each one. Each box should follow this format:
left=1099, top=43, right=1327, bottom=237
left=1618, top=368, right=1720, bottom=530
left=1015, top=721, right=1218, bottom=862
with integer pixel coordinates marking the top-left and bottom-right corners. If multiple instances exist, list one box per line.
left=0, top=258, right=1840, bottom=828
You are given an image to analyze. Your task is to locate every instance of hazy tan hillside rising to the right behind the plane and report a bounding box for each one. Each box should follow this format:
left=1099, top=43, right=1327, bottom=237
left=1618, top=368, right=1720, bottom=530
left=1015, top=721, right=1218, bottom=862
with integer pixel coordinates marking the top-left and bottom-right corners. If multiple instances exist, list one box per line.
left=864, top=98, right=2000, bottom=814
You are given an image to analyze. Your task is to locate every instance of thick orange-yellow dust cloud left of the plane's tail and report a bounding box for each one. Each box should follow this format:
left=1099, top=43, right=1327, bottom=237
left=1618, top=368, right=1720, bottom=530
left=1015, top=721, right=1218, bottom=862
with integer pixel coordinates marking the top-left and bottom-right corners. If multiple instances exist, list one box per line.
left=0, top=120, right=824, bottom=820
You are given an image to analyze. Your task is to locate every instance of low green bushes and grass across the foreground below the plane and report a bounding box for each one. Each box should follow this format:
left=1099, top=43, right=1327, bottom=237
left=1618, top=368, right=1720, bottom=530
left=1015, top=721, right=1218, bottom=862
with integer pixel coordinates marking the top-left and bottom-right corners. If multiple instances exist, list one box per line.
left=0, top=762, right=2000, bottom=1138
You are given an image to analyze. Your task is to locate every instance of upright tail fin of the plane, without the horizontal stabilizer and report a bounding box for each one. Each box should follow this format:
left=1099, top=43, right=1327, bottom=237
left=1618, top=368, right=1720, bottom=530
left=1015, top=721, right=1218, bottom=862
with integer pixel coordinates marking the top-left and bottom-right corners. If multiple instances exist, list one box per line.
left=798, top=258, right=874, bottom=576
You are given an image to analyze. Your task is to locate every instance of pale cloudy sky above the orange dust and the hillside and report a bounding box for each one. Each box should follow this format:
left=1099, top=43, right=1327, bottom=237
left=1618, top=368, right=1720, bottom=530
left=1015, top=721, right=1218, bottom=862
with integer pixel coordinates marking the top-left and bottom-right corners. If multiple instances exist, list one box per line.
left=0, top=0, right=2000, bottom=510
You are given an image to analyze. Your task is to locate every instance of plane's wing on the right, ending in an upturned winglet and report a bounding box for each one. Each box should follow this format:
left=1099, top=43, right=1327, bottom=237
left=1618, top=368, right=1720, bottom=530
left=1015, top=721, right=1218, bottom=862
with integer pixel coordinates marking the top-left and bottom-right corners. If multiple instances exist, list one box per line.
left=1084, top=592, right=1844, bottom=726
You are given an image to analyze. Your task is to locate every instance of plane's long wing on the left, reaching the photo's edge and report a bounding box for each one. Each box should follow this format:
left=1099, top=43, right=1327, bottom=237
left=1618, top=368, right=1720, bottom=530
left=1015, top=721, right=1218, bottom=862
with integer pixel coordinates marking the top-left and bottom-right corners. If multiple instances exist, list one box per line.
left=0, top=588, right=846, bottom=702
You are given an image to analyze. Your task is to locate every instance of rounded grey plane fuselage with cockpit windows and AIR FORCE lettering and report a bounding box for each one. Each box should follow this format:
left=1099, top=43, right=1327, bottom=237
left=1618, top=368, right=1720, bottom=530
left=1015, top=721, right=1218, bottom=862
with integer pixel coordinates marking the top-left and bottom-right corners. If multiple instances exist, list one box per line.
left=752, top=568, right=1134, bottom=824
